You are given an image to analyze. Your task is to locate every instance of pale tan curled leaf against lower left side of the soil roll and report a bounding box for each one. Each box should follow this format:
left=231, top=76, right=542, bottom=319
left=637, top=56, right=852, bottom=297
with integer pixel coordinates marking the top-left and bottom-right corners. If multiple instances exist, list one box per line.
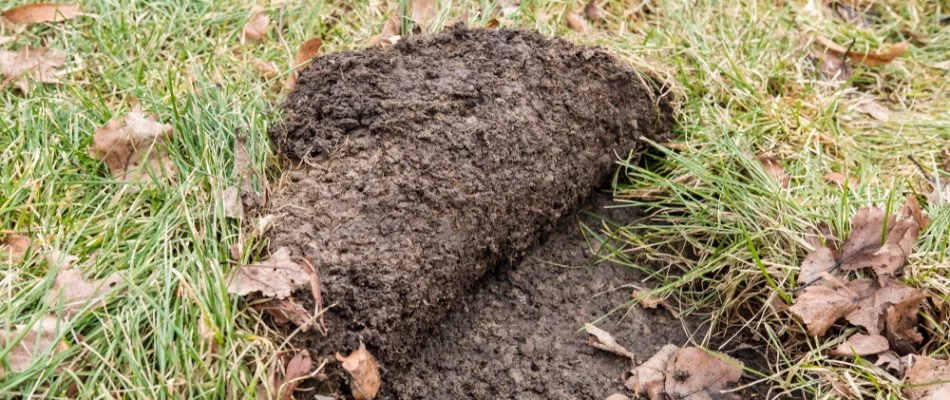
left=228, top=247, right=310, bottom=299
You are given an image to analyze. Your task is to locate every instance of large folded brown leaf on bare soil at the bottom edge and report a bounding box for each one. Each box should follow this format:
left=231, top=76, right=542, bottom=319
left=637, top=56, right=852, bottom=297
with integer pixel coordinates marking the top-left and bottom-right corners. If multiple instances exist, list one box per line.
left=624, top=345, right=742, bottom=400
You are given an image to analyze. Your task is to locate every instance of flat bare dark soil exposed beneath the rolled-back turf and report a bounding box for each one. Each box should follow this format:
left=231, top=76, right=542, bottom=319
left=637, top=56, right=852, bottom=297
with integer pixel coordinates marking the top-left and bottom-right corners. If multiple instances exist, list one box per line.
left=383, top=193, right=686, bottom=400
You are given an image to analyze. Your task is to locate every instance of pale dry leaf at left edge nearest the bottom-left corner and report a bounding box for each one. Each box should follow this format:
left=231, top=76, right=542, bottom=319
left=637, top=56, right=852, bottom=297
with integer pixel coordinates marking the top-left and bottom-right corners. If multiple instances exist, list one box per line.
left=0, top=316, right=69, bottom=376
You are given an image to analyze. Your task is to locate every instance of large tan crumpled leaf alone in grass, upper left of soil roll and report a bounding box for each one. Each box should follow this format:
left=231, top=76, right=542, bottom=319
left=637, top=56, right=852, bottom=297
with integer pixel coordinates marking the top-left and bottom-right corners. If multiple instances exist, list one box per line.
left=89, top=105, right=175, bottom=181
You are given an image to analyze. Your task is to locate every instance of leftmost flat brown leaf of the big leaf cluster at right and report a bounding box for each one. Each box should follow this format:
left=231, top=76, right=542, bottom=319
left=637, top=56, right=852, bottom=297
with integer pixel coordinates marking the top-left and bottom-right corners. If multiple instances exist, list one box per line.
left=789, top=286, right=858, bottom=336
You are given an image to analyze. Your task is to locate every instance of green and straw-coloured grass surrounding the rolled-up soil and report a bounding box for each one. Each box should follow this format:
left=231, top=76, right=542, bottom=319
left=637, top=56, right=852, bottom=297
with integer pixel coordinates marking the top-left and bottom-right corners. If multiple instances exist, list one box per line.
left=0, top=0, right=950, bottom=399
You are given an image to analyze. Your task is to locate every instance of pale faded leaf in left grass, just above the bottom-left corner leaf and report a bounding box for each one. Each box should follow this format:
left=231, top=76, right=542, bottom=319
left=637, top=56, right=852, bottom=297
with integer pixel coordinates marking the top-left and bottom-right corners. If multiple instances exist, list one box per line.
left=46, top=268, right=123, bottom=315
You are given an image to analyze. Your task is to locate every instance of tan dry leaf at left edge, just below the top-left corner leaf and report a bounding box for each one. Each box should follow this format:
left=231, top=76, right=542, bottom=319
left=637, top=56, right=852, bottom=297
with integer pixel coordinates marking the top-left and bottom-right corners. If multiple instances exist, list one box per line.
left=0, top=47, right=66, bottom=93
